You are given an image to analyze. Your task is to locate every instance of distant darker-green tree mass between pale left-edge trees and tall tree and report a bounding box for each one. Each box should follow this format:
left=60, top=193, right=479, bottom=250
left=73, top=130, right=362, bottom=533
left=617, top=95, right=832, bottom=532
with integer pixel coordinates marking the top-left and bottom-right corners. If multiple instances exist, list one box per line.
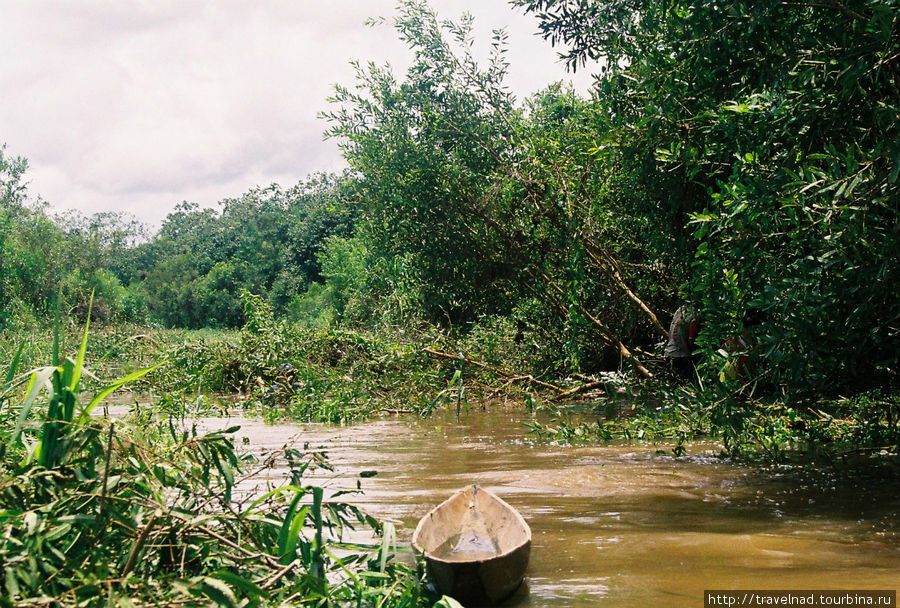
left=119, top=176, right=353, bottom=328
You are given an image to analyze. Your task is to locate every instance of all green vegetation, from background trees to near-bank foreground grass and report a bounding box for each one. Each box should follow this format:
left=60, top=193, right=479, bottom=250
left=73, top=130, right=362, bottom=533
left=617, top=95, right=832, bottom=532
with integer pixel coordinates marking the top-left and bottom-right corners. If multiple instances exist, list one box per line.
left=0, top=0, right=900, bottom=606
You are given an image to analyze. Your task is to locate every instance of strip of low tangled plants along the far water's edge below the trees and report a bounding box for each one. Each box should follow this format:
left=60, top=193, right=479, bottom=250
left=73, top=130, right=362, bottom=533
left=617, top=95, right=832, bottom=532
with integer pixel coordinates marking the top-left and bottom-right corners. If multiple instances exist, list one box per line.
left=7, top=312, right=900, bottom=470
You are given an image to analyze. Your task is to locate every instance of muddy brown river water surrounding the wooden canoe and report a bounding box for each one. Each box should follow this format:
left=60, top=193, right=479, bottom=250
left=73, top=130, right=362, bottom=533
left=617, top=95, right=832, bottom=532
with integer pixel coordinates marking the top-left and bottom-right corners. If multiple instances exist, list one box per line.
left=188, top=407, right=900, bottom=608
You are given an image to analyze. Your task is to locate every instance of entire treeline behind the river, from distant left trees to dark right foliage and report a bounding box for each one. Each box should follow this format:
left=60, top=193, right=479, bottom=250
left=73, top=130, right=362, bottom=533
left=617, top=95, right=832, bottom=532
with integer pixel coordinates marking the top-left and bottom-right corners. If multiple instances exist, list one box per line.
left=0, top=0, right=900, bottom=404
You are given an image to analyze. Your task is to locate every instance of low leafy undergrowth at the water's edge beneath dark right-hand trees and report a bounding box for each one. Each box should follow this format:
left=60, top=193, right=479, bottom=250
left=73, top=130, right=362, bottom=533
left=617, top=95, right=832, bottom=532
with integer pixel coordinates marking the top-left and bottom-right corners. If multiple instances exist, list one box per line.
left=527, top=382, right=900, bottom=469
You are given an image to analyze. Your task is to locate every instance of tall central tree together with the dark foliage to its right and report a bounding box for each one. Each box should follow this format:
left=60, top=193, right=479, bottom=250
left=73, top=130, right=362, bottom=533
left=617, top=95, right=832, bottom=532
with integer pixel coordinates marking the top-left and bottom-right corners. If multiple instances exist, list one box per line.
left=320, top=1, right=900, bottom=394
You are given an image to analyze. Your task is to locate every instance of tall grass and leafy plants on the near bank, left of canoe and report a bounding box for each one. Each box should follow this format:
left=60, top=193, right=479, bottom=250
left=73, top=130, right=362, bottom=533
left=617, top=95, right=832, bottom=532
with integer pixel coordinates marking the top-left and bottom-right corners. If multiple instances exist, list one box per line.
left=0, top=312, right=447, bottom=607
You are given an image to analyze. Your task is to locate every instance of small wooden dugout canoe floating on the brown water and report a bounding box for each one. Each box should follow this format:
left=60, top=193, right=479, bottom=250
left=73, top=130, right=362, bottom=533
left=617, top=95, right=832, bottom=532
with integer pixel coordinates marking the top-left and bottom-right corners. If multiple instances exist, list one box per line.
left=412, top=485, right=531, bottom=606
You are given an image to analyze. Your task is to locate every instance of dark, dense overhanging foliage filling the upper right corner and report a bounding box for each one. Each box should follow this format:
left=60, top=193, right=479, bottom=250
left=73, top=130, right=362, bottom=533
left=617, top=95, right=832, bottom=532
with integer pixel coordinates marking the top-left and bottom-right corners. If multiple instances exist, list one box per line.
left=516, top=0, right=900, bottom=391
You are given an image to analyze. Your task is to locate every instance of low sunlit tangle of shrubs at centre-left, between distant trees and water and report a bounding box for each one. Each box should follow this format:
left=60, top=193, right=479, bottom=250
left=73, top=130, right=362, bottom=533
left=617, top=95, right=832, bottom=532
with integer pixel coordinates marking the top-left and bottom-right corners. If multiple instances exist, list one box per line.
left=144, top=293, right=540, bottom=423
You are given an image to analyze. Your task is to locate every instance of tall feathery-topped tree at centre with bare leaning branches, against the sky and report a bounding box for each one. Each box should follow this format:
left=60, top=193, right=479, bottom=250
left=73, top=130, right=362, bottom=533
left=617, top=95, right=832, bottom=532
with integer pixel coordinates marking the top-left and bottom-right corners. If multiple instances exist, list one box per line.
left=326, top=1, right=684, bottom=374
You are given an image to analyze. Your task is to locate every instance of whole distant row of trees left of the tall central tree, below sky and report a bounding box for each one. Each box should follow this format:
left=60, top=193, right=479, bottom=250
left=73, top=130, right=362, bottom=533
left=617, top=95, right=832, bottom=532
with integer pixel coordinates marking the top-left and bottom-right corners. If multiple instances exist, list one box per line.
left=0, top=159, right=355, bottom=328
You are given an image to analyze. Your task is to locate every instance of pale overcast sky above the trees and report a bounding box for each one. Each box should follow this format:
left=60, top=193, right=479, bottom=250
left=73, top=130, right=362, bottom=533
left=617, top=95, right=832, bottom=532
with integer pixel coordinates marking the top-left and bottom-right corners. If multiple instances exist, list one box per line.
left=0, top=0, right=590, bottom=227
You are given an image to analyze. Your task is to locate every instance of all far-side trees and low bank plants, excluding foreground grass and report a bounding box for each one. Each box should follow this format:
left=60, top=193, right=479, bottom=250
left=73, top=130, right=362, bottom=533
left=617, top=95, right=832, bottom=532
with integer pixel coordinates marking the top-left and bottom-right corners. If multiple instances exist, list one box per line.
left=0, top=0, right=900, bottom=498
